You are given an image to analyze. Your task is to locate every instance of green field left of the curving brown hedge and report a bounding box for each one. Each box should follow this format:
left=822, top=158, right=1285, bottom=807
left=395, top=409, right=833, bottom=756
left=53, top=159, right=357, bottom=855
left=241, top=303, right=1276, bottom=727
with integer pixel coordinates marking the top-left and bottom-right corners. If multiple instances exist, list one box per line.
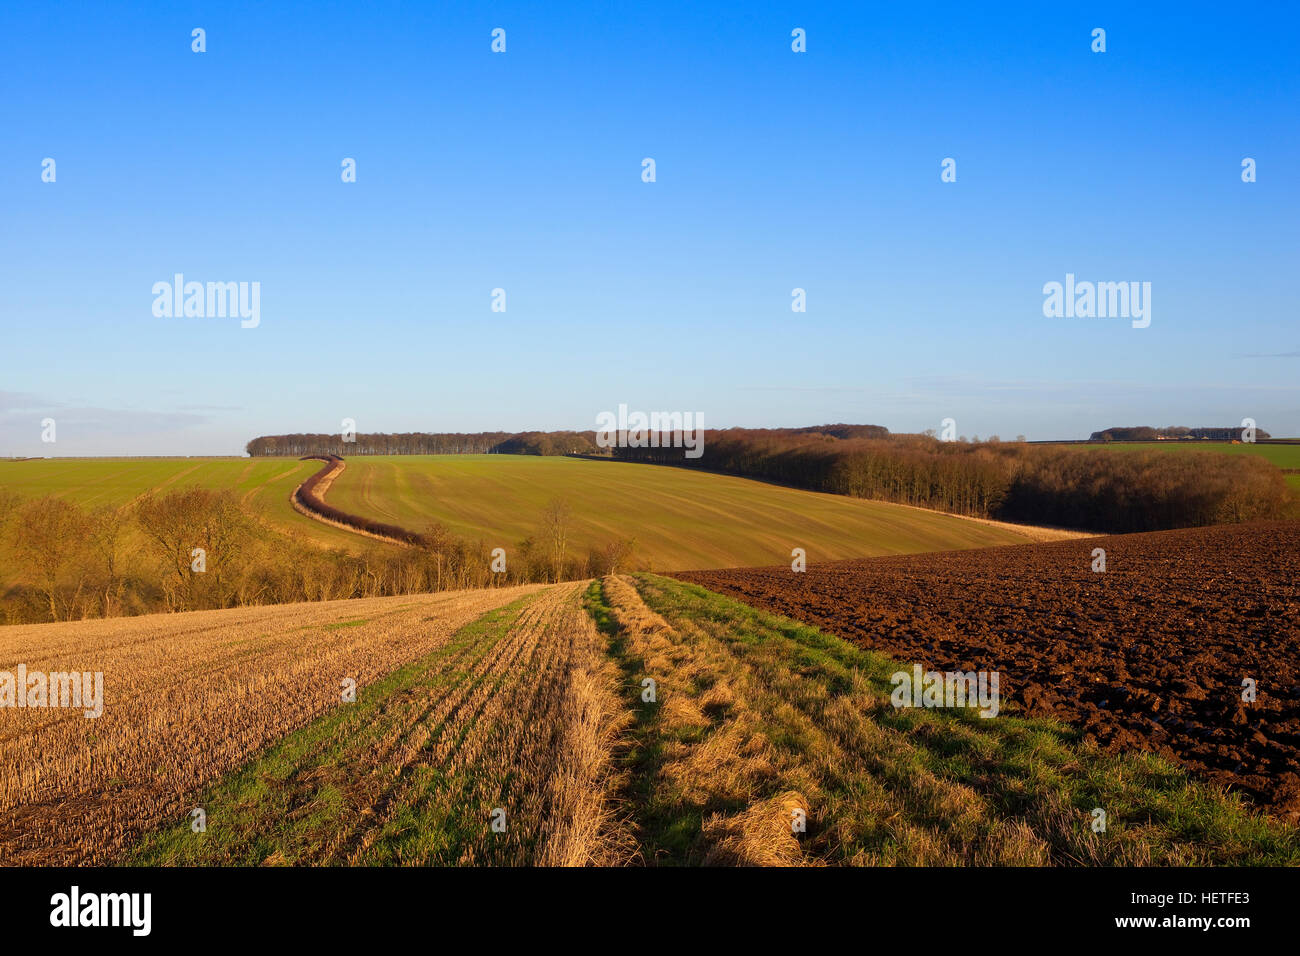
left=0, top=458, right=359, bottom=549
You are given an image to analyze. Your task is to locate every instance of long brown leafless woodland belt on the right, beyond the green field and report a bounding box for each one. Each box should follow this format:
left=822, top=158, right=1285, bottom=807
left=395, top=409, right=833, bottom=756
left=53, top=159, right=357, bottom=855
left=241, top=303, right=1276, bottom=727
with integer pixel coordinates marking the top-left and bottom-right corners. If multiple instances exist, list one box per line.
left=612, top=428, right=1297, bottom=533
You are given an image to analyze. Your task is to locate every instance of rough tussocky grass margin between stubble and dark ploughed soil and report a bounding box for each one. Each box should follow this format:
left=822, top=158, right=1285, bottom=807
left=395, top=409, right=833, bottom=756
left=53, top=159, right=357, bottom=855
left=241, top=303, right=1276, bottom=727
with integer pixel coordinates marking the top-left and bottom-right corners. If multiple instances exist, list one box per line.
left=589, top=575, right=1300, bottom=866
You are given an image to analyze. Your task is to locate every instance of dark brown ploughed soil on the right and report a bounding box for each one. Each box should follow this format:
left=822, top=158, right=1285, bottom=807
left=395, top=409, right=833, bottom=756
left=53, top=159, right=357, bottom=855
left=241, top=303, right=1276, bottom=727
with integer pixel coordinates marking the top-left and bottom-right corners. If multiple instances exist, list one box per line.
left=677, top=522, right=1300, bottom=819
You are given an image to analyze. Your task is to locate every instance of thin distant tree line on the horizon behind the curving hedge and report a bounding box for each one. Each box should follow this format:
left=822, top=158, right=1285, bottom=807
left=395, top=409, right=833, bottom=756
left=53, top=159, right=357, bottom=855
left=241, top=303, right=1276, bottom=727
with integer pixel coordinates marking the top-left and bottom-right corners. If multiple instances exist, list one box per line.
left=244, top=431, right=602, bottom=458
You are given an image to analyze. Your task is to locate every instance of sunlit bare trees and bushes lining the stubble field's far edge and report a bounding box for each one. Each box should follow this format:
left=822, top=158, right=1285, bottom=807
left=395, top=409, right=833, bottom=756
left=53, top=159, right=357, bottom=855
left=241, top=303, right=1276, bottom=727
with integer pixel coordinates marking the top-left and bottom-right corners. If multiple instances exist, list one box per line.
left=0, top=486, right=637, bottom=624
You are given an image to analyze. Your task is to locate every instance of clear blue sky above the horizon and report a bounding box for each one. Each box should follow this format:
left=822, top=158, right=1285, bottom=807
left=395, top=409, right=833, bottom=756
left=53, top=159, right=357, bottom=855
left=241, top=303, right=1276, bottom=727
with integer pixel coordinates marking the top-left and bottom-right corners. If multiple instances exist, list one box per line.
left=0, top=3, right=1300, bottom=455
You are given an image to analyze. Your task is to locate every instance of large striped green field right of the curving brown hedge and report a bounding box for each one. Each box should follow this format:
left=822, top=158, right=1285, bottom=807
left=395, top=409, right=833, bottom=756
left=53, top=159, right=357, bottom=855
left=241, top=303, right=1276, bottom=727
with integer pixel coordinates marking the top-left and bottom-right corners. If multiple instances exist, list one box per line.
left=328, top=455, right=1026, bottom=570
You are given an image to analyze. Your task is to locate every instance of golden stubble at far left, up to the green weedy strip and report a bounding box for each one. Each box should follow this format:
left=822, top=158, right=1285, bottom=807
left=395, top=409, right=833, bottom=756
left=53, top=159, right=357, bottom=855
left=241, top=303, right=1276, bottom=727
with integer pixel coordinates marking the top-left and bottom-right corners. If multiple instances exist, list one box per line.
left=0, top=587, right=538, bottom=865
